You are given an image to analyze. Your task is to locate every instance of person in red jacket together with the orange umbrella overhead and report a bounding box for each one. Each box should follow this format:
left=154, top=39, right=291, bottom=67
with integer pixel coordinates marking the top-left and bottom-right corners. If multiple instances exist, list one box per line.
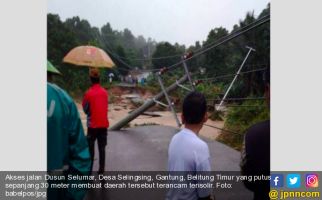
left=63, top=46, right=115, bottom=174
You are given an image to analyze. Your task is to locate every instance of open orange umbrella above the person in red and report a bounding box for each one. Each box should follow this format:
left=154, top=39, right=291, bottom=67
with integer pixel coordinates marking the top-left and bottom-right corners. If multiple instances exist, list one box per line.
left=63, top=46, right=115, bottom=68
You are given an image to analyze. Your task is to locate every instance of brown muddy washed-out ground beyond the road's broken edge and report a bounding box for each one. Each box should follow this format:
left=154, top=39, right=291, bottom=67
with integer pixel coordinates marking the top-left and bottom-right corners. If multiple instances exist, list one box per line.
left=77, top=86, right=224, bottom=140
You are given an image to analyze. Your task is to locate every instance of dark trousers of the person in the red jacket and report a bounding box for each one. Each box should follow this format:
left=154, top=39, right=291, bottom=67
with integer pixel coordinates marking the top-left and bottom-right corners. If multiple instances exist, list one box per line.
left=87, top=128, right=107, bottom=172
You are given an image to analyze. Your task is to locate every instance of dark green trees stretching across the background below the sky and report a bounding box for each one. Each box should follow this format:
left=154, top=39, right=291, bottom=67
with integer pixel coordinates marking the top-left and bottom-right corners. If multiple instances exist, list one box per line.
left=47, top=2, right=270, bottom=97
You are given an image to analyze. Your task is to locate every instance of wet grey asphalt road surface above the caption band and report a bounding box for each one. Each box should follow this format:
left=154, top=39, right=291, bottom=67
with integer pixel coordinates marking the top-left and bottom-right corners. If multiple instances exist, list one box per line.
left=90, top=126, right=240, bottom=171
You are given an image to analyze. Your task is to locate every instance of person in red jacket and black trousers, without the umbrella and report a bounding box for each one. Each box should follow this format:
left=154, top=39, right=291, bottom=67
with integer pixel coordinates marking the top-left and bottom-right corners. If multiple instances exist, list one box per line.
left=82, top=68, right=109, bottom=173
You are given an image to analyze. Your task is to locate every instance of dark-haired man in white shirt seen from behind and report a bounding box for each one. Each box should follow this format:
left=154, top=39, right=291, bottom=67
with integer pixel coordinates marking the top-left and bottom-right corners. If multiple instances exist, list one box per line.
left=167, top=92, right=211, bottom=200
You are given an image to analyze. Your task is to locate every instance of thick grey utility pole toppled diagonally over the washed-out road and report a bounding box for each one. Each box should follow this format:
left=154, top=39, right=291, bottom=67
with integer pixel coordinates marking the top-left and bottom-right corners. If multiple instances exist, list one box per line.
left=109, top=75, right=188, bottom=131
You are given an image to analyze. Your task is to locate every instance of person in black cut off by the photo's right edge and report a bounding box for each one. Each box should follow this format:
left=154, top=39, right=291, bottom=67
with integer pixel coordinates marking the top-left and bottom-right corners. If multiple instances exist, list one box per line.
left=240, top=68, right=270, bottom=200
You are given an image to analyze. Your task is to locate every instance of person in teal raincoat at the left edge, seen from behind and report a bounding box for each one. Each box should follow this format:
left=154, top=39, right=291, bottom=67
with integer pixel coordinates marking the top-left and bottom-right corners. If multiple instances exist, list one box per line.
left=47, top=64, right=91, bottom=200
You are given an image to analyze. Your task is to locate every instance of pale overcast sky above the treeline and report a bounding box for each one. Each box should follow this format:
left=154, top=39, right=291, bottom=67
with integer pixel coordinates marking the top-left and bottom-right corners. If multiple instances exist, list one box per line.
left=47, top=0, right=270, bottom=45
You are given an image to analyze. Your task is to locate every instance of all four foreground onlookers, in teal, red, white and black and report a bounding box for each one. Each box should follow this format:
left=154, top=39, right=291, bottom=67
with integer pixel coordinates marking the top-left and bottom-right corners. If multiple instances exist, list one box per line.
left=47, top=64, right=270, bottom=200
